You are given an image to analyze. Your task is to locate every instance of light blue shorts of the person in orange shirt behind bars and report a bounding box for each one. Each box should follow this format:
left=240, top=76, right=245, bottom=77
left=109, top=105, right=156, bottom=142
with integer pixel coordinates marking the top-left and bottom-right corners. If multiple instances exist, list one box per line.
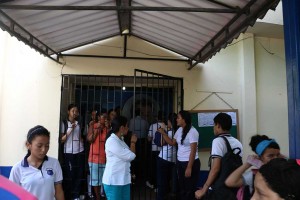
left=89, top=162, right=105, bottom=186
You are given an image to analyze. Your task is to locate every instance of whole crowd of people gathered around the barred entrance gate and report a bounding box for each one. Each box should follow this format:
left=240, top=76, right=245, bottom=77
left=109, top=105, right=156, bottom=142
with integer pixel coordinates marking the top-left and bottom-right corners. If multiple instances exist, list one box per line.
left=9, top=104, right=300, bottom=200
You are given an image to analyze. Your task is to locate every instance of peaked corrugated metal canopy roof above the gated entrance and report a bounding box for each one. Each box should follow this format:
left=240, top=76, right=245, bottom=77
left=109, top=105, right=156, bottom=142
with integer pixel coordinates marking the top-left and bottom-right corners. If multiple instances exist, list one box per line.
left=0, top=0, right=279, bottom=68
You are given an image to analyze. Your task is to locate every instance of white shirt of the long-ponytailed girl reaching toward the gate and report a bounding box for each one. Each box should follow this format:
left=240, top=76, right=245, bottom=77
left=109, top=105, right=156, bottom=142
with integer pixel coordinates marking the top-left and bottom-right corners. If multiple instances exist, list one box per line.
left=174, top=126, right=199, bottom=162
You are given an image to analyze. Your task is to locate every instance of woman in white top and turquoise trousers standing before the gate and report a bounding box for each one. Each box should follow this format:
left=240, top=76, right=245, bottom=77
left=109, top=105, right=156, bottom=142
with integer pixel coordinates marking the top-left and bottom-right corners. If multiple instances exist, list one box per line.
left=102, top=116, right=137, bottom=200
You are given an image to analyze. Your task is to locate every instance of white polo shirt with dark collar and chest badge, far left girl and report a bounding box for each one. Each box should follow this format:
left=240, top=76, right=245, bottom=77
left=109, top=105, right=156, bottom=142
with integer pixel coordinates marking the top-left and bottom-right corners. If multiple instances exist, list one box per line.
left=9, top=156, right=63, bottom=200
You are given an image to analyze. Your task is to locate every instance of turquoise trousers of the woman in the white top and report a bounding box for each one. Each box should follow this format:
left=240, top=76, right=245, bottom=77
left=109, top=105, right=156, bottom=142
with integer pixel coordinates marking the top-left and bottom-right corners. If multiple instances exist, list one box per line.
left=103, top=184, right=130, bottom=200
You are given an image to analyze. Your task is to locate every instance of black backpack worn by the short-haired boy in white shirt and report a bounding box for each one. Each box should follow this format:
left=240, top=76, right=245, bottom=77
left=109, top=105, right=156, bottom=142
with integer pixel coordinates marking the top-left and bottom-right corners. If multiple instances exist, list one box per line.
left=212, top=136, right=243, bottom=200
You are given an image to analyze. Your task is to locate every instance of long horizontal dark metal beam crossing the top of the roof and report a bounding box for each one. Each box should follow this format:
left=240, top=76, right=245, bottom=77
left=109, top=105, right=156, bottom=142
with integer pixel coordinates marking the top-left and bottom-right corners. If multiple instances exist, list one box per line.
left=0, top=4, right=240, bottom=13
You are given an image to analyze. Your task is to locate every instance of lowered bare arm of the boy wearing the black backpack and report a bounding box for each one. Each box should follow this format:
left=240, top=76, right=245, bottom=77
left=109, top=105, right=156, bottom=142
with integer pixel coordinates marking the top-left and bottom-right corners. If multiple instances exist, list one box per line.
left=195, top=157, right=221, bottom=199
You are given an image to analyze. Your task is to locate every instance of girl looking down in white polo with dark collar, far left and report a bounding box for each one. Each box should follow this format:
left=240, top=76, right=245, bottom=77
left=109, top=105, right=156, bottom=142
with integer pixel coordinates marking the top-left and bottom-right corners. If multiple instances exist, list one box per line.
left=9, top=126, right=65, bottom=200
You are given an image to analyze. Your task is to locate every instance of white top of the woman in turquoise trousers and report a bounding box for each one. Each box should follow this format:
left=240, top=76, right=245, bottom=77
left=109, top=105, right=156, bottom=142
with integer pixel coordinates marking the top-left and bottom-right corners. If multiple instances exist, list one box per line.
left=102, top=133, right=135, bottom=185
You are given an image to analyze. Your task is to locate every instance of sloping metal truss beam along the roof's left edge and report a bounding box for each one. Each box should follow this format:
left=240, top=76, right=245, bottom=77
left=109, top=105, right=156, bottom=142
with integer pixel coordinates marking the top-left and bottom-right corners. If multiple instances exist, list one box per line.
left=0, top=10, right=61, bottom=64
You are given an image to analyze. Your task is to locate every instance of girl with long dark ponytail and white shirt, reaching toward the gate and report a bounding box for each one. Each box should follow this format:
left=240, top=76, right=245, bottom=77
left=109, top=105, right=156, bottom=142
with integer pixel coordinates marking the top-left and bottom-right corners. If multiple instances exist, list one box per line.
left=160, top=110, right=200, bottom=200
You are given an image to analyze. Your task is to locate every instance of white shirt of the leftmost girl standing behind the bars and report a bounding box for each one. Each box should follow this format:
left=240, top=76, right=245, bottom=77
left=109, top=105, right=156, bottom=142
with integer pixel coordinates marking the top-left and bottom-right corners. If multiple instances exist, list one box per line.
left=61, top=120, right=84, bottom=154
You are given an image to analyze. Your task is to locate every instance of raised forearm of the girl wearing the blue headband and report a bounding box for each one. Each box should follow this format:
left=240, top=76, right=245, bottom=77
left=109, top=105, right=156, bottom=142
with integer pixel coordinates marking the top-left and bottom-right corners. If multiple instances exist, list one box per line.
left=225, top=162, right=251, bottom=187
